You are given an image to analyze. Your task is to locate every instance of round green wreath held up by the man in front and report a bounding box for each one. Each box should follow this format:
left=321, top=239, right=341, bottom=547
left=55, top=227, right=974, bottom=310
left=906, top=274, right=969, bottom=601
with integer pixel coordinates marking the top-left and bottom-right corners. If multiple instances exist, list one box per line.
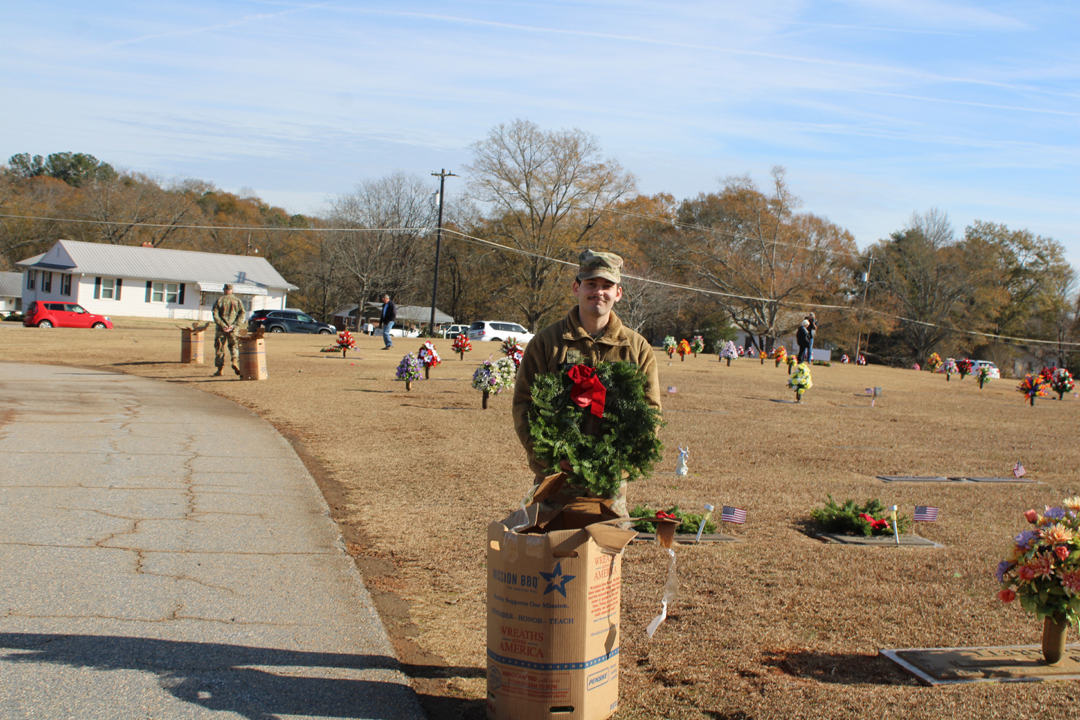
left=529, top=362, right=664, bottom=498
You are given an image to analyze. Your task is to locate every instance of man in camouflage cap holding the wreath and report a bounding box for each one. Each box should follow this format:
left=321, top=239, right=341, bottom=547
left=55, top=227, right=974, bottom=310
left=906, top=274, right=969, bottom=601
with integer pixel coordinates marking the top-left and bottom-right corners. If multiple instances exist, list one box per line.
left=513, top=250, right=660, bottom=517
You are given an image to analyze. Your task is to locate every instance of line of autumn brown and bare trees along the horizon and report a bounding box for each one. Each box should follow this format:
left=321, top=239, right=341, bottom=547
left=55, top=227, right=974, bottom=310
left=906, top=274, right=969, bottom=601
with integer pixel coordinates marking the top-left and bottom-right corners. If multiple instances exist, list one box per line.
left=0, top=120, right=1080, bottom=365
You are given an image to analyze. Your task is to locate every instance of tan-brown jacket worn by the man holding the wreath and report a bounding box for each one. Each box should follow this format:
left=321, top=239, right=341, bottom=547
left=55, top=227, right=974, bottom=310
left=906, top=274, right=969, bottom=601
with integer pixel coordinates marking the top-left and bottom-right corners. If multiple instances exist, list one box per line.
left=514, top=307, right=660, bottom=477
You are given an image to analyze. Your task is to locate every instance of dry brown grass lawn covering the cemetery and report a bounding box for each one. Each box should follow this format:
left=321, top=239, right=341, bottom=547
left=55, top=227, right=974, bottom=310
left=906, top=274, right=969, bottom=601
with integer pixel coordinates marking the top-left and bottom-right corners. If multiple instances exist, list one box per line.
left=0, top=318, right=1080, bottom=720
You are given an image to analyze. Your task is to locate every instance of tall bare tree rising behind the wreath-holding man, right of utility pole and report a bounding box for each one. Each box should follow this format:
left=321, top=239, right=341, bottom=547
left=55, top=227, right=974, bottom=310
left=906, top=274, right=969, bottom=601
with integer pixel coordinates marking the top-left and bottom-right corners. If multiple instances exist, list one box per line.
left=467, top=120, right=634, bottom=330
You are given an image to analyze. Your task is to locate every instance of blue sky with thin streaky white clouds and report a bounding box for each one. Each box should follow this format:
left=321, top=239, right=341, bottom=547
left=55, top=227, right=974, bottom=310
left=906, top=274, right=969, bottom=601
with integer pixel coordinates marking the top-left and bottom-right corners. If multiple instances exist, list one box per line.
left=0, top=0, right=1080, bottom=262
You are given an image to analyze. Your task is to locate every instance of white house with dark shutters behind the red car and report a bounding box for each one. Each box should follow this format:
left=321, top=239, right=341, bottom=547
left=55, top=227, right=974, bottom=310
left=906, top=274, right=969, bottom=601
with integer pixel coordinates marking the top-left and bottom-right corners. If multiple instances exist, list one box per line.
left=16, top=240, right=297, bottom=321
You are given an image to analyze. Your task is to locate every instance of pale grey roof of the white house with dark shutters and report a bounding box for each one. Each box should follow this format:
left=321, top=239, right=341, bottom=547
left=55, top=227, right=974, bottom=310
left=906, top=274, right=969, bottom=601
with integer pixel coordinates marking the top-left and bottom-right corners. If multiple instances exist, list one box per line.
left=16, top=240, right=297, bottom=290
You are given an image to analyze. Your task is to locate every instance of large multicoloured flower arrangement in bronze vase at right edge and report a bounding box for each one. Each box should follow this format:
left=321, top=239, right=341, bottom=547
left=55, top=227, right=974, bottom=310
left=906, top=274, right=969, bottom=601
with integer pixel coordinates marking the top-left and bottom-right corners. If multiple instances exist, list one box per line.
left=995, top=498, right=1080, bottom=664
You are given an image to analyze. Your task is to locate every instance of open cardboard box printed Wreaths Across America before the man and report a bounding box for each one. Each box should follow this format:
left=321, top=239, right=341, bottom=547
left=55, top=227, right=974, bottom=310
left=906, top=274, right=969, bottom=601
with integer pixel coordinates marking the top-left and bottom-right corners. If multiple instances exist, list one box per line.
left=487, top=505, right=637, bottom=720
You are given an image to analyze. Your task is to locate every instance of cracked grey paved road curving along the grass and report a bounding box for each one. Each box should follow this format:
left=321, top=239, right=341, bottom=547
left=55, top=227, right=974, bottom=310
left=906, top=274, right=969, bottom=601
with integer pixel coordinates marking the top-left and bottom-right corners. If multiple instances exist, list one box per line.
left=0, top=363, right=423, bottom=720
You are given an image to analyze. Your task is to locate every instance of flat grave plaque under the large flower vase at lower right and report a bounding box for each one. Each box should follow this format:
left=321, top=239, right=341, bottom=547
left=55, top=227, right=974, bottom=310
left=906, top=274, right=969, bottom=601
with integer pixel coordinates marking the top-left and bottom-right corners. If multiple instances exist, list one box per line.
left=880, top=644, right=1080, bottom=685
